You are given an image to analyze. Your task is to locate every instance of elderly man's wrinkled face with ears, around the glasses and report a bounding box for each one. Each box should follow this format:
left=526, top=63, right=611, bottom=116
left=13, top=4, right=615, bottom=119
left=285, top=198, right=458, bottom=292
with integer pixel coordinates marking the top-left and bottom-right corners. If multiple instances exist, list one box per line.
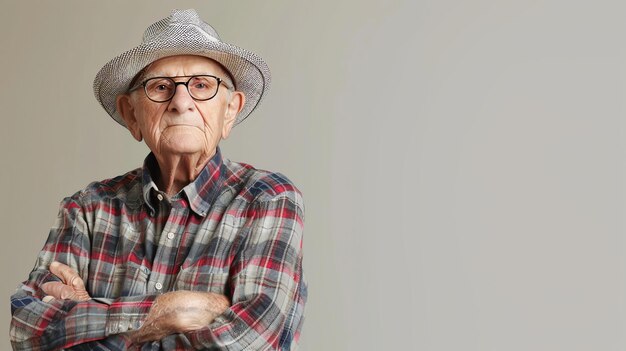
left=118, top=56, right=244, bottom=161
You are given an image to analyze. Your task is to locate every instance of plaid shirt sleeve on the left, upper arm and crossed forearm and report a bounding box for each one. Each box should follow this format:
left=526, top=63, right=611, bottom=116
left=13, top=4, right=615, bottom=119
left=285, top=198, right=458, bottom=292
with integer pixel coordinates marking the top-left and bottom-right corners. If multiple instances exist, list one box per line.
left=10, top=198, right=156, bottom=350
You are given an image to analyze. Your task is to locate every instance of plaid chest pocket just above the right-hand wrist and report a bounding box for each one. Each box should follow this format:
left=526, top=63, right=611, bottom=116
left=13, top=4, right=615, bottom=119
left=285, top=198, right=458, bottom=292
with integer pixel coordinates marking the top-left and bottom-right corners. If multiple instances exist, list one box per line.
left=175, top=266, right=230, bottom=295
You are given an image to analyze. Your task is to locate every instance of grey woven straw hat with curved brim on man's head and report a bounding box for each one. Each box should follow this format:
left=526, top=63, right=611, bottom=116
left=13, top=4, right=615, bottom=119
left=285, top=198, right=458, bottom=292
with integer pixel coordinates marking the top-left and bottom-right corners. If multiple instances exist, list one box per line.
left=93, top=10, right=271, bottom=126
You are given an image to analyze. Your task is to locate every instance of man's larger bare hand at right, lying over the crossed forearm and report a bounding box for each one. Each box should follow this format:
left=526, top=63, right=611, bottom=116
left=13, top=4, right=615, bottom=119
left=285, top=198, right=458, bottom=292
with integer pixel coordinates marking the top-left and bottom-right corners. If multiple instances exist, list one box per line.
left=128, top=291, right=230, bottom=343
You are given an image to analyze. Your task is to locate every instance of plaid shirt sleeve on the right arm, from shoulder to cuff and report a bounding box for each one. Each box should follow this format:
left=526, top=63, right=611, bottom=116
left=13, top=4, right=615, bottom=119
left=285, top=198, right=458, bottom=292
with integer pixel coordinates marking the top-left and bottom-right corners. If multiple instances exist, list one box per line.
left=186, top=191, right=306, bottom=350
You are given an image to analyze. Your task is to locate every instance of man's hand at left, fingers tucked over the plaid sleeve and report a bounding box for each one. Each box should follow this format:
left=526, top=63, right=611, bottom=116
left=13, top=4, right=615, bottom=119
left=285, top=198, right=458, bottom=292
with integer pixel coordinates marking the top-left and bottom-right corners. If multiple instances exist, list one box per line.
left=41, top=262, right=91, bottom=302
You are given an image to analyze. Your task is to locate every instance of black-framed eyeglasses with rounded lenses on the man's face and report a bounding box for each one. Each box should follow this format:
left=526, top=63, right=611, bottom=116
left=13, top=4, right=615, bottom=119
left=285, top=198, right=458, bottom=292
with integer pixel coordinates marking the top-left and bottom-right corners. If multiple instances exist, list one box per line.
left=130, top=74, right=229, bottom=102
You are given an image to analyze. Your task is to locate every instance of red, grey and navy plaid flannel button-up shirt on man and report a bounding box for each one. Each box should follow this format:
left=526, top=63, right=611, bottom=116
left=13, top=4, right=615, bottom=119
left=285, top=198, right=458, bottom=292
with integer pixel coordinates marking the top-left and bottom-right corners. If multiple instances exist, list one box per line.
left=10, top=149, right=307, bottom=350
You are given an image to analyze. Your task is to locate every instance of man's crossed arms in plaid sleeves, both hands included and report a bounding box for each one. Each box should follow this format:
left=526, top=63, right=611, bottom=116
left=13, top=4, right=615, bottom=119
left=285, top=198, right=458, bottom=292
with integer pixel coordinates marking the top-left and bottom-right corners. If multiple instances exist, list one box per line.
left=10, top=193, right=306, bottom=350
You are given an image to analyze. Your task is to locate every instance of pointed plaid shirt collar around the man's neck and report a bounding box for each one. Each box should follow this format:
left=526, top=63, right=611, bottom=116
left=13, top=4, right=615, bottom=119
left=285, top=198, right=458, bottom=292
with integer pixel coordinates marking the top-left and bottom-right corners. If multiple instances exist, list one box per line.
left=142, top=147, right=226, bottom=217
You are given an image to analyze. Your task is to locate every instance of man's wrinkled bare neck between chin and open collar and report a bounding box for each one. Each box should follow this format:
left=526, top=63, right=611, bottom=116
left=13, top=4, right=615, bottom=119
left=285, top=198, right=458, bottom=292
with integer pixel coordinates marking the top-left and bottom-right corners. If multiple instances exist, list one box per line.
left=154, top=150, right=215, bottom=196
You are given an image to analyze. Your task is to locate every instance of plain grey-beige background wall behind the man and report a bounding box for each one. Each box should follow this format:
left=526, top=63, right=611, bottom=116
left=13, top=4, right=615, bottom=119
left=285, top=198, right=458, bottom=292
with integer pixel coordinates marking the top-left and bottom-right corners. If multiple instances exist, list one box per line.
left=0, top=0, right=626, bottom=351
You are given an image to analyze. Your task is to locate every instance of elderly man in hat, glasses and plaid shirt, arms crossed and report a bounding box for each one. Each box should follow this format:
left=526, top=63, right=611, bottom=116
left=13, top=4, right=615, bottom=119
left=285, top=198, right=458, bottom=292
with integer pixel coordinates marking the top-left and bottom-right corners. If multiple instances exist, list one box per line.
left=10, top=10, right=306, bottom=350
